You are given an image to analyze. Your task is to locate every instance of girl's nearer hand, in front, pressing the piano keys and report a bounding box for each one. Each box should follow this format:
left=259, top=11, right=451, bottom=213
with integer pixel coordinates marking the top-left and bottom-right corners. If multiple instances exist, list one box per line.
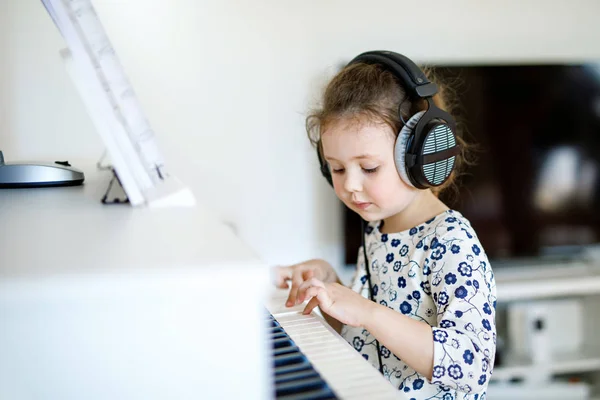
left=296, top=278, right=376, bottom=326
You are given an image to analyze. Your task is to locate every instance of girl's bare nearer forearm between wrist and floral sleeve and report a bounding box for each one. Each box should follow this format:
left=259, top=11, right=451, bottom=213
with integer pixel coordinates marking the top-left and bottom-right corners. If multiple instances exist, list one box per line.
left=363, top=302, right=433, bottom=381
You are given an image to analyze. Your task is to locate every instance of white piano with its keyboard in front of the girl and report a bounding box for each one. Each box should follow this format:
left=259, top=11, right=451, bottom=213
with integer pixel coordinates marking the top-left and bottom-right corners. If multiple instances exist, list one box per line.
left=0, top=169, right=398, bottom=400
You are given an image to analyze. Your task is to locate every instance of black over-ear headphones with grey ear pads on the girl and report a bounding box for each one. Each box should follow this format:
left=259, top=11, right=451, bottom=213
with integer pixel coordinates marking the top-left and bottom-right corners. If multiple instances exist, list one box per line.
left=317, top=51, right=460, bottom=189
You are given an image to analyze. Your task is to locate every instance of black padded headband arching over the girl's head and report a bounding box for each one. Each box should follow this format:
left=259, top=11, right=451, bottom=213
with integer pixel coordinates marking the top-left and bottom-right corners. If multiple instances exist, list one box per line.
left=348, top=50, right=438, bottom=98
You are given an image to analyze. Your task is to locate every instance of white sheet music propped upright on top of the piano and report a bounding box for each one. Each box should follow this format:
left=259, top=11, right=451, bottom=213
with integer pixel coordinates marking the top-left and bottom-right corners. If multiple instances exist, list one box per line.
left=42, top=0, right=195, bottom=207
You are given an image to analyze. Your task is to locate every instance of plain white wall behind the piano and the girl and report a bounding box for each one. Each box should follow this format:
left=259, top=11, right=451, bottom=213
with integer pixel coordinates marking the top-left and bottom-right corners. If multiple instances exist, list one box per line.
left=0, top=0, right=600, bottom=264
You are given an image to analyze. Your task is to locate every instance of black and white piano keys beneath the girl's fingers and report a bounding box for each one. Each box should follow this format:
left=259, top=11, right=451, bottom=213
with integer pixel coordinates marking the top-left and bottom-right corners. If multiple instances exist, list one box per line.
left=267, top=290, right=400, bottom=400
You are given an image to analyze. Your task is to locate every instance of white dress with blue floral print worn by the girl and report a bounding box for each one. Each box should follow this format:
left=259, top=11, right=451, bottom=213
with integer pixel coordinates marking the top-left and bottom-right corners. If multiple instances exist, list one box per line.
left=342, top=210, right=496, bottom=400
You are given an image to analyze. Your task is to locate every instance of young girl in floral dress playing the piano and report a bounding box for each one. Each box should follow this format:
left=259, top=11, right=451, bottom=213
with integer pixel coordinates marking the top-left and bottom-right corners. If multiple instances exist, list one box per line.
left=276, top=52, right=496, bottom=400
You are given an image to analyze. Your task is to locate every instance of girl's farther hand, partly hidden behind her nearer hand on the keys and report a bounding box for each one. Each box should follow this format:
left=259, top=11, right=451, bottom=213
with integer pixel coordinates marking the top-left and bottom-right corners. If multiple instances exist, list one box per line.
left=273, top=259, right=339, bottom=307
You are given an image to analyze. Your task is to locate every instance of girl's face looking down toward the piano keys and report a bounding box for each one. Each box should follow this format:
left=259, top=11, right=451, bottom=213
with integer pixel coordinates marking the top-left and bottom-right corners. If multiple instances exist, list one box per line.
left=321, top=118, right=419, bottom=221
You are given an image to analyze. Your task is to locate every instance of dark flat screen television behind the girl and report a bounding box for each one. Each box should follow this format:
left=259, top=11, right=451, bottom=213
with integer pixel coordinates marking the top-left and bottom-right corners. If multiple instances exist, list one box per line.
left=344, top=64, right=600, bottom=264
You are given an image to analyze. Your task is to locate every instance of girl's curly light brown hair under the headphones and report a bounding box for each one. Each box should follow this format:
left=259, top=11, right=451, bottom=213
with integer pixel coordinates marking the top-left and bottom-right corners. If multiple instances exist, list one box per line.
left=306, top=63, right=469, bottom=195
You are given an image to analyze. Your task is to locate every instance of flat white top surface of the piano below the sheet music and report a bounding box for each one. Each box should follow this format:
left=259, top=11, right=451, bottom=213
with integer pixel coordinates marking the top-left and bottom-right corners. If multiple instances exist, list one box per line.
left=0, top=168, right=262, bottom=279
